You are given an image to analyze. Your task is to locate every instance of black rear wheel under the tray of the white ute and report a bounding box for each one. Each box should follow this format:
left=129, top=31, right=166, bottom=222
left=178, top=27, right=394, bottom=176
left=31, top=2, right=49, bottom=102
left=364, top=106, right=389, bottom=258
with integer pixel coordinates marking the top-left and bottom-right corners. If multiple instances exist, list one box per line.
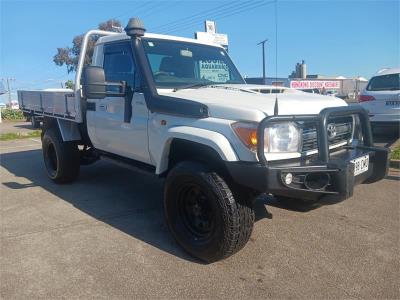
left=42, top=128, right=80, bottom=183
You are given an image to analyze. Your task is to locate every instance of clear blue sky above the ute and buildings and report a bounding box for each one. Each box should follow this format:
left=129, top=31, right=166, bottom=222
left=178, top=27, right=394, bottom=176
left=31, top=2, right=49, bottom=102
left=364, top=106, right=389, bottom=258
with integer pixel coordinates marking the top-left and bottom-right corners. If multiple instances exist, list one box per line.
left=0, top=0, right=400, bottom=102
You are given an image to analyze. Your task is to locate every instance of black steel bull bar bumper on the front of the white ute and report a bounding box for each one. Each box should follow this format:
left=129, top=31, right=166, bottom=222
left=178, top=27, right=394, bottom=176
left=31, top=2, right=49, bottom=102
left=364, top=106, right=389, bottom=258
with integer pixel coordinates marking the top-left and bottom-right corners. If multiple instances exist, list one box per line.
left=226, top=107, right=390, bottom=200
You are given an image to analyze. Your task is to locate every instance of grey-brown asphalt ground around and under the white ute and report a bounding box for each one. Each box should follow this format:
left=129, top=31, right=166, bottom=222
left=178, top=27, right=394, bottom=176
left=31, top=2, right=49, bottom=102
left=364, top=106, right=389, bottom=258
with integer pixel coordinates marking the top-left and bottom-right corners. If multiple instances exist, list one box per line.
left=0, top=139, right=400, bottom=299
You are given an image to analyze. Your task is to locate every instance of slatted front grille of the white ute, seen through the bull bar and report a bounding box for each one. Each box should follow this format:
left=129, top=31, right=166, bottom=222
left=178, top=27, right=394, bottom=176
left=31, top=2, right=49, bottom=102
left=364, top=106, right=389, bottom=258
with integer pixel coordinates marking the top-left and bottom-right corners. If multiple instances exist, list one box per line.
left=302, top=116, right=353, bottom=152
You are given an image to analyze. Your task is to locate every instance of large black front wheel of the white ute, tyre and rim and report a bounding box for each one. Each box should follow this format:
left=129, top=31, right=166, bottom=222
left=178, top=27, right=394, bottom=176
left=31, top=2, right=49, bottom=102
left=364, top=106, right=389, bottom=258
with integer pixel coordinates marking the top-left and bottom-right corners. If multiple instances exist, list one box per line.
left=164, top=162, right=254, bottom=262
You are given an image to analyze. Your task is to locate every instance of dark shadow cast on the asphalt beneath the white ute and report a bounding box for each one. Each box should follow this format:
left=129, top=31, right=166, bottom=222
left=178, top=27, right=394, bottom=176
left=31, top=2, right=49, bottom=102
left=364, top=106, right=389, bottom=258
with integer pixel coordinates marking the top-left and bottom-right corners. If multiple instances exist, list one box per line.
left=0, top=150, right=272, bottom=264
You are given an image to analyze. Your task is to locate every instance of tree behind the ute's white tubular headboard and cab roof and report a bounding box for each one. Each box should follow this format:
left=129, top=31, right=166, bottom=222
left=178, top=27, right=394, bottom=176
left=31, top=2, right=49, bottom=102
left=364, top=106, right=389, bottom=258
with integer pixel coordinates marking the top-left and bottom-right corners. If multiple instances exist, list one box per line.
left=53, top=19, right=121, bottom=73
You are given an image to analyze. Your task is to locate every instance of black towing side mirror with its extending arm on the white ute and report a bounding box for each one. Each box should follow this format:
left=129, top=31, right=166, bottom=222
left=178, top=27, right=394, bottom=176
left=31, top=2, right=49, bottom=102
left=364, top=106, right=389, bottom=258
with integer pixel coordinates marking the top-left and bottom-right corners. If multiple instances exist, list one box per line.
left=82, top=66, right=126, bottom=99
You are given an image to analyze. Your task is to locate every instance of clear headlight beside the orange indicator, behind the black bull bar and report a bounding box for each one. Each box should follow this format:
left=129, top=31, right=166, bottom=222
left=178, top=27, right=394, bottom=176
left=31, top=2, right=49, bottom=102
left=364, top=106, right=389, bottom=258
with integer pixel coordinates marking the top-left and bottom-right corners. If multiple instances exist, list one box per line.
left=264, top=122, right=302, bottom=152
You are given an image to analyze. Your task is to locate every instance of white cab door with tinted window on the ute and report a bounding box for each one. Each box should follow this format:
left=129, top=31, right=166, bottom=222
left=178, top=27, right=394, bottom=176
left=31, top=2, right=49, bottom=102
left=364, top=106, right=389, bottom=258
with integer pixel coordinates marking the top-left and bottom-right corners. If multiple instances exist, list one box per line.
left=95, top=42, right=150, bottom=163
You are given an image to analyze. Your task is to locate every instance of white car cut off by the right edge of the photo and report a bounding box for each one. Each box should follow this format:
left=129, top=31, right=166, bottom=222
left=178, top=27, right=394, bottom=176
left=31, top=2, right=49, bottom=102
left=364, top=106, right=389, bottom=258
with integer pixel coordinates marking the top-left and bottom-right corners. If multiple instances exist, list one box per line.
left=359, top=68, right=400, bottom=127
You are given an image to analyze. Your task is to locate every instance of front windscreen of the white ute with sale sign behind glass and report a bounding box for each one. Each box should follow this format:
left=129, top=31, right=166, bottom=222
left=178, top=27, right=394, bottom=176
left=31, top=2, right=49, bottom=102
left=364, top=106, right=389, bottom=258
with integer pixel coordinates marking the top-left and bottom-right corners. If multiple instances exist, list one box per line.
left=143, top=38, right=245, bottom=88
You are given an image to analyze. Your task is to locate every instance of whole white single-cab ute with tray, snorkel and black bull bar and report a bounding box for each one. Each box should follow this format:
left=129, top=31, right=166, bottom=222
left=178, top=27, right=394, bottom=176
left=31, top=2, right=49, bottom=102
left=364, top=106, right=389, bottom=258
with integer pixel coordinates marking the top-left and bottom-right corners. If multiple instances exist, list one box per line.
left=18, top=19, right=388, bottom=262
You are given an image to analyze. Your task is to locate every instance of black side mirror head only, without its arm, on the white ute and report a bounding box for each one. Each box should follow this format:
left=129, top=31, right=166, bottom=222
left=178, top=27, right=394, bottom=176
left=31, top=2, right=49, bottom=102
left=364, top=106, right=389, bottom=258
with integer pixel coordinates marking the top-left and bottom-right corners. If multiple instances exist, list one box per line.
left=82, top=66, right=106, bottom=99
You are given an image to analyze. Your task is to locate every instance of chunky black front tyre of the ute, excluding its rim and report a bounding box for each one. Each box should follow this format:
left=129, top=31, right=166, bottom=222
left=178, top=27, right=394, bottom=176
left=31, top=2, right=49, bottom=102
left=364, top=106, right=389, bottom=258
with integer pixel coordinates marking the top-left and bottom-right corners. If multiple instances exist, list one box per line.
left=164, top=162, right=254, bottom=262
